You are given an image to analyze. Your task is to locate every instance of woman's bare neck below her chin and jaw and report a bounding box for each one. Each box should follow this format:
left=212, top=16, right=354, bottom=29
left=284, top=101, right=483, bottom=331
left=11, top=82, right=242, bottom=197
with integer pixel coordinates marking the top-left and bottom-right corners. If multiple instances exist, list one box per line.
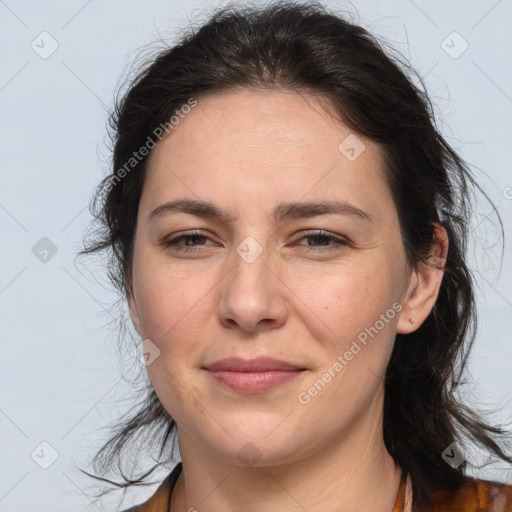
left=171, top=390, right=401, bottom=512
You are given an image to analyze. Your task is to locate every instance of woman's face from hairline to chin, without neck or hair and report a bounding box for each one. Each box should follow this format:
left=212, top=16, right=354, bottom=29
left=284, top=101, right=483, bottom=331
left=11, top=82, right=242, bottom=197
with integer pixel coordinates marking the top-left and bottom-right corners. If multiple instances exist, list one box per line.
left=129, top=91, right=421, bottom=465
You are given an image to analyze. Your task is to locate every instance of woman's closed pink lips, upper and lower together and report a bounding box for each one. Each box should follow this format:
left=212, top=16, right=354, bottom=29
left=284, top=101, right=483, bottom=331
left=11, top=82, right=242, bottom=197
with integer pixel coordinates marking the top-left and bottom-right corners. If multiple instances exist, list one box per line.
left=205, top=357, right=305, bottom=393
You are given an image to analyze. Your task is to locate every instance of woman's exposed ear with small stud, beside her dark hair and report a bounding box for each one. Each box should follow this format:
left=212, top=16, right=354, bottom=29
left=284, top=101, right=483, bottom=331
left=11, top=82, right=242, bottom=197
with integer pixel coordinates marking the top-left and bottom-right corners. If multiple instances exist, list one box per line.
left=397, top=224, right=449, bottom=334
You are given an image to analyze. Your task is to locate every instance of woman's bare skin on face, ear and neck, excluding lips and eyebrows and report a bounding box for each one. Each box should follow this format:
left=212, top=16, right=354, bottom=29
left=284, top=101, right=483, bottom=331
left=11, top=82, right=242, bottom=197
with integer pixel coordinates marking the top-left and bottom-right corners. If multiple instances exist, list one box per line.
left=128, top=90, right=448, bottom=512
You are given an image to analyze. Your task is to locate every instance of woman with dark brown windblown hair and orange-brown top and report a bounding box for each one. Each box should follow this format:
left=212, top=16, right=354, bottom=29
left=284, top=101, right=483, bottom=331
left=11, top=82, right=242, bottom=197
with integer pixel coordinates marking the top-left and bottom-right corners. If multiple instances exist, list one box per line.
left=80, top=3, right=512, bottom=512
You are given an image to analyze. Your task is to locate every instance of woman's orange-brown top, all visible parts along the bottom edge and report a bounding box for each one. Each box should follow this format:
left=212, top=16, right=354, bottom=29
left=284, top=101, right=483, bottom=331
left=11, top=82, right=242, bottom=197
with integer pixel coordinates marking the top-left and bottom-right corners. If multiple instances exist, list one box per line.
left=124, top=462, right=512, bottom=512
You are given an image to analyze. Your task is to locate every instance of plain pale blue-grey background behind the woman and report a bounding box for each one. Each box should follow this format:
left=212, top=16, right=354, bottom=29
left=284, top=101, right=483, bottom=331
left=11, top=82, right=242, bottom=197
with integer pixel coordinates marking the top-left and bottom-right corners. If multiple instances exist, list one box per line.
left=0, top=0, right=512, bottom=512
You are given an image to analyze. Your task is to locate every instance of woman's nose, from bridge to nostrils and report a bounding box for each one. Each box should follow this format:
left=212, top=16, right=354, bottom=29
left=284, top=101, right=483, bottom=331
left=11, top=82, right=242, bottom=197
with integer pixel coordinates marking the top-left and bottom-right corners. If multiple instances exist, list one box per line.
left=217, top=244, right=289, bottom=332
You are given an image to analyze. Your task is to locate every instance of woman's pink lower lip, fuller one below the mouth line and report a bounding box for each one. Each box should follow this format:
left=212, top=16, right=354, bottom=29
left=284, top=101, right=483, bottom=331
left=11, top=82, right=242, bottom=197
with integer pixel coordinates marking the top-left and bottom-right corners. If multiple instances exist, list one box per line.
left=208, top=370, right=303, bottom=393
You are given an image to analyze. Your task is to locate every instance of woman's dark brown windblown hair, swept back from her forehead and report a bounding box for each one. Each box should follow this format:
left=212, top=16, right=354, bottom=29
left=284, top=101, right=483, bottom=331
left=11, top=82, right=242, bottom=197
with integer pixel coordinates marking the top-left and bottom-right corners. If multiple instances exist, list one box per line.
left=82, top=2, right=512, bottom=506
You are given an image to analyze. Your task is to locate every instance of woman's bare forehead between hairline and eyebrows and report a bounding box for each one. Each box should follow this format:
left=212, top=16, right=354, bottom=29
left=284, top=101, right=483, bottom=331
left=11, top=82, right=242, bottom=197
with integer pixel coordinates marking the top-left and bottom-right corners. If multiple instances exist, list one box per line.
left=141, top=90, right=391, bottom=220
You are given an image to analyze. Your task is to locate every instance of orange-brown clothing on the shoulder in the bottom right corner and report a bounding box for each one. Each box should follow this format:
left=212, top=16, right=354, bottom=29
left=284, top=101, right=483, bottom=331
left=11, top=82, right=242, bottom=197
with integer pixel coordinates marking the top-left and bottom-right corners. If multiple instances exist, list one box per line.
left=430, top=477, right=512, bottom=512
